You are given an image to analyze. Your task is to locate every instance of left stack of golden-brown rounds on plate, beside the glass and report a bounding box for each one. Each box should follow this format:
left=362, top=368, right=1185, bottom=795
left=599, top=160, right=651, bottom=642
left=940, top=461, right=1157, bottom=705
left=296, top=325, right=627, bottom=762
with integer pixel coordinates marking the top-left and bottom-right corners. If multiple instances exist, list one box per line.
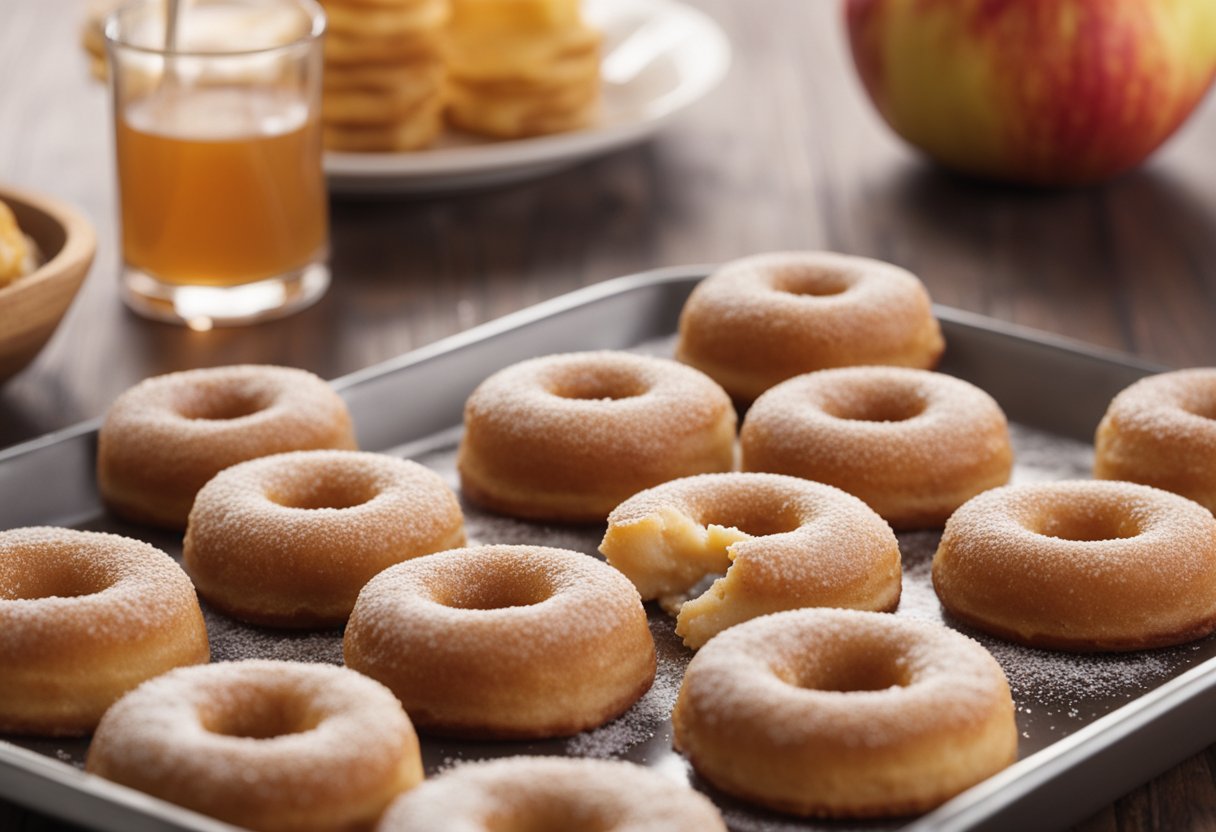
left=321, top=0, right=449, bottom=151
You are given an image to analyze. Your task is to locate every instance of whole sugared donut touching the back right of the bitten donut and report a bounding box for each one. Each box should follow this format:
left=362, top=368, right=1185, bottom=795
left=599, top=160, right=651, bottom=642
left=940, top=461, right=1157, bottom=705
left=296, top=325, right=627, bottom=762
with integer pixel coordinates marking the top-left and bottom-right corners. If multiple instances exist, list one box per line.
left=739, top=367, right=1013, bottom=529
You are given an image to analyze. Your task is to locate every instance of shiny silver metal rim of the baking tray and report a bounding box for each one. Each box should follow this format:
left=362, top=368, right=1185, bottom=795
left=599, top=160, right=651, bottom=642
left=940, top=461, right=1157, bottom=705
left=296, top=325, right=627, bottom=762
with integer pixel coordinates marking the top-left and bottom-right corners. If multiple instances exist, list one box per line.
left=0, top=264, right=1201, bottom=832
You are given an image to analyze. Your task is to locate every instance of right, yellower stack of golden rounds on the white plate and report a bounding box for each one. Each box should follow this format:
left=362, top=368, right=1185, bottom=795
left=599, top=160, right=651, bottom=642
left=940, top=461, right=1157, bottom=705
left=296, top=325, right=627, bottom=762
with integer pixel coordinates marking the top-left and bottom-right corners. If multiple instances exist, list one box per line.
left=447, top=0, right=601, bottom=139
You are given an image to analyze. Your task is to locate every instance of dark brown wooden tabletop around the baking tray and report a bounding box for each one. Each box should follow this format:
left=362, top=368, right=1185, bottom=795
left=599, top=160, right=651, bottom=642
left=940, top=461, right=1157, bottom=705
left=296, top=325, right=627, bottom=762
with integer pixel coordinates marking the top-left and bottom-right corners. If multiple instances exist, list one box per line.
left=0, top=0, right=1216, bottom=832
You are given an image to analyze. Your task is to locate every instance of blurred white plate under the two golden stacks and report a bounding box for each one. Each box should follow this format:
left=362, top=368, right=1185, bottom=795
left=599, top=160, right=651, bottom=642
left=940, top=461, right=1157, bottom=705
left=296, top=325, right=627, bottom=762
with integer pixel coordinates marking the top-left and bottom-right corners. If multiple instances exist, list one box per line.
left=325, top=0, right=731, bottom=193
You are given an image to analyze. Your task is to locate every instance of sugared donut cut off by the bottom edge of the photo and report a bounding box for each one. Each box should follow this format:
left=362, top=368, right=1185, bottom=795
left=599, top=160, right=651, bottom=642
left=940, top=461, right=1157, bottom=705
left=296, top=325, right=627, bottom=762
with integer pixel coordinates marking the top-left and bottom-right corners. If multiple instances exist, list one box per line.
left=376, top=757, right=726, bottom=832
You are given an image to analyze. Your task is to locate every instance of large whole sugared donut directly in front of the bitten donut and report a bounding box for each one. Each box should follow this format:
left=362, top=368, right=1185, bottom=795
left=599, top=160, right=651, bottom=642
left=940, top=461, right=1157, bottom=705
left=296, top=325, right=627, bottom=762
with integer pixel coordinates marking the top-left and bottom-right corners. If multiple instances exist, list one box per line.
left=671, top=609, right=1018, bottom=817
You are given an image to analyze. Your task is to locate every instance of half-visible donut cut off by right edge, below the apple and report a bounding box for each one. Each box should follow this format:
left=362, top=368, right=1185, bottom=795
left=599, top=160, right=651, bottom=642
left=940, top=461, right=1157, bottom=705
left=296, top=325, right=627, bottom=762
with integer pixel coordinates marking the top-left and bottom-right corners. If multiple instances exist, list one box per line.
left=1093, top=367, right=1216, bottom=512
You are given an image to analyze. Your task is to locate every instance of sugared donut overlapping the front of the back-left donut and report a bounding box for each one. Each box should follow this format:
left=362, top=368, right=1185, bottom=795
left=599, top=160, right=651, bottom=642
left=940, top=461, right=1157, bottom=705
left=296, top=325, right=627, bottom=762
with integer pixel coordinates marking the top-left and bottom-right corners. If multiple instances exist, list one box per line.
left=182, top=450, right=465, bottom=626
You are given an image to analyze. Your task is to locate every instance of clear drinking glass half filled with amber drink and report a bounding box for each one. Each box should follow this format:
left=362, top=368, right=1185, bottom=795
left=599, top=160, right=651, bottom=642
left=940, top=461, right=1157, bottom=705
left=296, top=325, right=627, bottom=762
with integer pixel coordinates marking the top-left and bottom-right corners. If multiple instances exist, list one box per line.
left=106, top=0, right=330, bottom=330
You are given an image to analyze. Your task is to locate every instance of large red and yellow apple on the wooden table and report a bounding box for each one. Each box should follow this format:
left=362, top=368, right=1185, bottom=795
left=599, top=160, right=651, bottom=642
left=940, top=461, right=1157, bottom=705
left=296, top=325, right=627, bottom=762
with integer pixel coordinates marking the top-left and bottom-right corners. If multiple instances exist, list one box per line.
left=845, top=0, right=1216, bottom=186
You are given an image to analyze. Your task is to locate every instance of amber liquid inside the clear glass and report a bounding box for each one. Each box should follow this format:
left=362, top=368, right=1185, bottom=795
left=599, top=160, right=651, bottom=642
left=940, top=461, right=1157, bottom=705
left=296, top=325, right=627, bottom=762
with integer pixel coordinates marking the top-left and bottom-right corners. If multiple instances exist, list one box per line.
left=117, top=88, right=328, bottom=286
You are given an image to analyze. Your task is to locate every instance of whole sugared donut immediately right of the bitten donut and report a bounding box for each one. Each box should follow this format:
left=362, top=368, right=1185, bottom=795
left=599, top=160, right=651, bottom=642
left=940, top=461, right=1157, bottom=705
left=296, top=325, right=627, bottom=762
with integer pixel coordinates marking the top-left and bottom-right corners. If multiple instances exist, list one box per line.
left=933, top=480, right=1216, bottom=651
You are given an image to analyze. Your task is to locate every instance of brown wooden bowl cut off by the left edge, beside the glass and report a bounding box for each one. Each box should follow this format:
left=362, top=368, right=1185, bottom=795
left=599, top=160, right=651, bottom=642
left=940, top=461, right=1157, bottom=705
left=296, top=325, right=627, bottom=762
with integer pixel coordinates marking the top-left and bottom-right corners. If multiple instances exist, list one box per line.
left=0, top=187, right=97, bottom=382
